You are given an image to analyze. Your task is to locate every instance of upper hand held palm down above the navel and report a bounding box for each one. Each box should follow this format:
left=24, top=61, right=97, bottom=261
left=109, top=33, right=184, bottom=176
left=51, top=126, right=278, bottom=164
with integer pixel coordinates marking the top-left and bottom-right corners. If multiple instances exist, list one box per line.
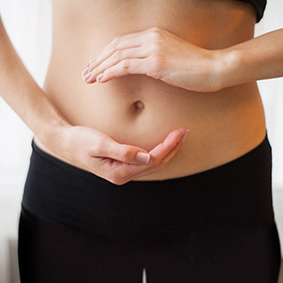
left=82, top=28, right=222, bottom=92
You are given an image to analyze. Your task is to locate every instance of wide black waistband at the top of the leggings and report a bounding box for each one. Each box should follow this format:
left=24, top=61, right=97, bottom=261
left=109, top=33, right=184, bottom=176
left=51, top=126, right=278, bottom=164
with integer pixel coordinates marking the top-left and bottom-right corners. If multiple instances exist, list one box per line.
left=23, top=137, right=273, bottom=239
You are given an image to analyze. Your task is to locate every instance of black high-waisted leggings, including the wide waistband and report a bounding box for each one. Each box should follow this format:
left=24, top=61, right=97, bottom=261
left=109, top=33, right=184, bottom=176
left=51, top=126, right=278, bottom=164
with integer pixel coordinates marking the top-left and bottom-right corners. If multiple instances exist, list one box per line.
left=19, top=138, right=280, bottom=283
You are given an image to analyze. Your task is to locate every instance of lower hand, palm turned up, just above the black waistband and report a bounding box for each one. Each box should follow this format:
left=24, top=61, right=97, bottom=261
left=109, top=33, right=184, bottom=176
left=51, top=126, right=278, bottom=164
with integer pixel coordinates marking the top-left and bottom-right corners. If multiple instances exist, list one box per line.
left=59, top=126, right=188, bottom=185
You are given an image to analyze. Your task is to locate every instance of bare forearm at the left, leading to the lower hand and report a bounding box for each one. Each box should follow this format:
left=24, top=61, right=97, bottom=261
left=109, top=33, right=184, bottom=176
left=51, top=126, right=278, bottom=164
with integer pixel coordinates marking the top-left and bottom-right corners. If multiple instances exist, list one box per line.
left=0, top=19, right=68, bottom=153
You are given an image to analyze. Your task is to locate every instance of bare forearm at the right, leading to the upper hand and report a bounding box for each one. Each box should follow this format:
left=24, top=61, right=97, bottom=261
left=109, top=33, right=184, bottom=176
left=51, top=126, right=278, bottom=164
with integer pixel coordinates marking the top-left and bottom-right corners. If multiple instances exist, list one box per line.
left=219, top=29, right=283, bottom=87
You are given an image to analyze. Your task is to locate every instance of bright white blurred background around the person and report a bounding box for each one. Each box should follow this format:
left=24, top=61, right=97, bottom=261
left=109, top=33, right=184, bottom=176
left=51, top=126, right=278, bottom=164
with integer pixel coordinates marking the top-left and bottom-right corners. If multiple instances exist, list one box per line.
left=0, top=0, right=283, bottom=283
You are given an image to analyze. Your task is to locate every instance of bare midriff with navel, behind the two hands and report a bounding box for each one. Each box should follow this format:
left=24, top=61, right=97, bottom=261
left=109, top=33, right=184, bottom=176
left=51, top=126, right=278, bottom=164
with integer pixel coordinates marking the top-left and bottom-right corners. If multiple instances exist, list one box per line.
left=36, top=0, right=265, bottom=180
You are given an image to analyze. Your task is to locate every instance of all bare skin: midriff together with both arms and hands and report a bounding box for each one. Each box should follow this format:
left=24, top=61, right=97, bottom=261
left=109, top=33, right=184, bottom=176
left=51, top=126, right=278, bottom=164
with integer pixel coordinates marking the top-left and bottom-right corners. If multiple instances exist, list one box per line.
left=0, top=0, right=283, bottom=185
